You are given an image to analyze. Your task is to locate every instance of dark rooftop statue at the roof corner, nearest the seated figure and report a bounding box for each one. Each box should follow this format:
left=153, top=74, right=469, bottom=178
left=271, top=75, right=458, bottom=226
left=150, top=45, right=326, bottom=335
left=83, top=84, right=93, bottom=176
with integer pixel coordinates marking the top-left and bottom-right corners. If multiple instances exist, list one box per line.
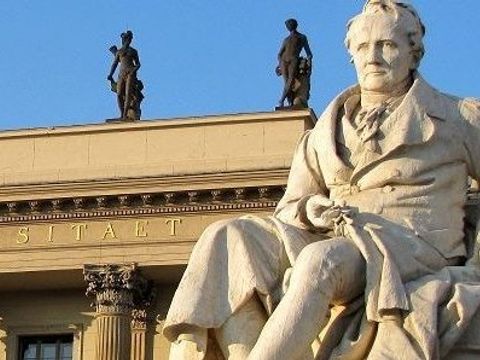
left=275, top=19, right=313, bottom=109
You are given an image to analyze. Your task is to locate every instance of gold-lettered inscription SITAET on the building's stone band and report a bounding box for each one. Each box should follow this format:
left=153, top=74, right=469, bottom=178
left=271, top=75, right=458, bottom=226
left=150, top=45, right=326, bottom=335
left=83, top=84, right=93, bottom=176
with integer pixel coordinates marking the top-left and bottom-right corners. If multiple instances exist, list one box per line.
left=6, top=217, right=188, bottom=247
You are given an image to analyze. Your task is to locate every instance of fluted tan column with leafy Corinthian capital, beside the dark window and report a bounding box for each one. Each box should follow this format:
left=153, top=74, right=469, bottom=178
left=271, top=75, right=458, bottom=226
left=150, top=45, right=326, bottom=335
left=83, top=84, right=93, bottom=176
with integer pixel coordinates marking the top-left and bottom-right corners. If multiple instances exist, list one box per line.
left=83, top=264, right=145, bottom=360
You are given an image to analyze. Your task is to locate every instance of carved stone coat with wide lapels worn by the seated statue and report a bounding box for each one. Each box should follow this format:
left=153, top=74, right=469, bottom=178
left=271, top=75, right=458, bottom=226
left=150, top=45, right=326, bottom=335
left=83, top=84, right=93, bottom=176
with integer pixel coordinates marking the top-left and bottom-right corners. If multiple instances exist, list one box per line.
left=275, top=76, right=480, bottom=359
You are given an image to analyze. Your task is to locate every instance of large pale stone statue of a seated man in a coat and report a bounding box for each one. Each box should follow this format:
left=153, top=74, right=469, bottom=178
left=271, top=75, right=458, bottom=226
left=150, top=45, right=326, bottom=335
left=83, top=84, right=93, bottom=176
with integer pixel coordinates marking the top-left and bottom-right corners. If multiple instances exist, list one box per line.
left=163, top=0, right=480, bottom=360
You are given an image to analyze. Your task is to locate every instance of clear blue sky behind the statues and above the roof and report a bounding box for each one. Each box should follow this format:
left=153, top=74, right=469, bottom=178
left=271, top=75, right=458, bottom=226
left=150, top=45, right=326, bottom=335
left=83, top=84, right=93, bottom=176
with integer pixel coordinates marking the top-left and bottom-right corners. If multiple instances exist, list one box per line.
left=0, top=0, right=480, bottom=129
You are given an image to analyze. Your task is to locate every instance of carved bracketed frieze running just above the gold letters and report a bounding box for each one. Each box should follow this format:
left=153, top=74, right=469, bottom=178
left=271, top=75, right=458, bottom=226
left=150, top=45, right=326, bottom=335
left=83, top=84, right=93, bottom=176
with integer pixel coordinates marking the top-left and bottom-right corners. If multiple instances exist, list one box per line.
left=0, top=186, right=284, bottom=223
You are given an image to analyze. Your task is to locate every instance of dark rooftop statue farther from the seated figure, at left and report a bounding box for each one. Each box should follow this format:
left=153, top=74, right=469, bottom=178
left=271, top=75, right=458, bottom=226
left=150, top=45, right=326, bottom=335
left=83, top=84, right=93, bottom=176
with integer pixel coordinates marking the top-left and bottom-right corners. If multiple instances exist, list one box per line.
left=107, top=30, right=143, bottom=121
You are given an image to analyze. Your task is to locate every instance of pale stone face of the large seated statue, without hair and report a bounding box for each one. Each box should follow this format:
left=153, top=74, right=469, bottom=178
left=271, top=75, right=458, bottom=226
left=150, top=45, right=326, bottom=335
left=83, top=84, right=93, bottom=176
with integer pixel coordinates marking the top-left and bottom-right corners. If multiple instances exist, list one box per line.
left=350, top=15, right=415, bottom=93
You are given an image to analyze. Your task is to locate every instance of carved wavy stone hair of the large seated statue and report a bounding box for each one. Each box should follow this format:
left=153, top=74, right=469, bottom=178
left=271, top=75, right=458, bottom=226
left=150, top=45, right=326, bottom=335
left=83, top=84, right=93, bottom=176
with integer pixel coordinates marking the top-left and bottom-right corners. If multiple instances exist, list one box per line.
left=345, top=0, right=425, bottom=63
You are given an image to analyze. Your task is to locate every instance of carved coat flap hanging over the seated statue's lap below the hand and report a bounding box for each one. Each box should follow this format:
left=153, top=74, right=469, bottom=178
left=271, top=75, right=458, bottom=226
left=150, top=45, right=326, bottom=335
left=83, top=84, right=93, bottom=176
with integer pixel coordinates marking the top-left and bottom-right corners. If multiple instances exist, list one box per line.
left=343, top=213, right=448, bottom=322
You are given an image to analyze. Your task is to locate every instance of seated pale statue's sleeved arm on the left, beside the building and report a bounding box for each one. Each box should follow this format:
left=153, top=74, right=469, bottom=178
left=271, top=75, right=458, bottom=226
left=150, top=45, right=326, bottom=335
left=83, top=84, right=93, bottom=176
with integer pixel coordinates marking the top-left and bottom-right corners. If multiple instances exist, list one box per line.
left=274, top=130, right=333, bottom=229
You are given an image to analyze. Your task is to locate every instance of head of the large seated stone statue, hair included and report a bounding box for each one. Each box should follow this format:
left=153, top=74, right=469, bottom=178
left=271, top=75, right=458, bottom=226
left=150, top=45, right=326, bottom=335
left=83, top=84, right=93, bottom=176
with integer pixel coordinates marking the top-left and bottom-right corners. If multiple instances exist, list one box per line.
left=345, top=0, right=425, bottom=92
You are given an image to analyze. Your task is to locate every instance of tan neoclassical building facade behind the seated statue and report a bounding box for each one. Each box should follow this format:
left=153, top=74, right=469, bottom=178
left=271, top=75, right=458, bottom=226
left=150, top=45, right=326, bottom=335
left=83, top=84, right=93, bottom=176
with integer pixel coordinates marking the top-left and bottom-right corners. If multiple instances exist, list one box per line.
left=0, top=110, right=316, bottom=360
